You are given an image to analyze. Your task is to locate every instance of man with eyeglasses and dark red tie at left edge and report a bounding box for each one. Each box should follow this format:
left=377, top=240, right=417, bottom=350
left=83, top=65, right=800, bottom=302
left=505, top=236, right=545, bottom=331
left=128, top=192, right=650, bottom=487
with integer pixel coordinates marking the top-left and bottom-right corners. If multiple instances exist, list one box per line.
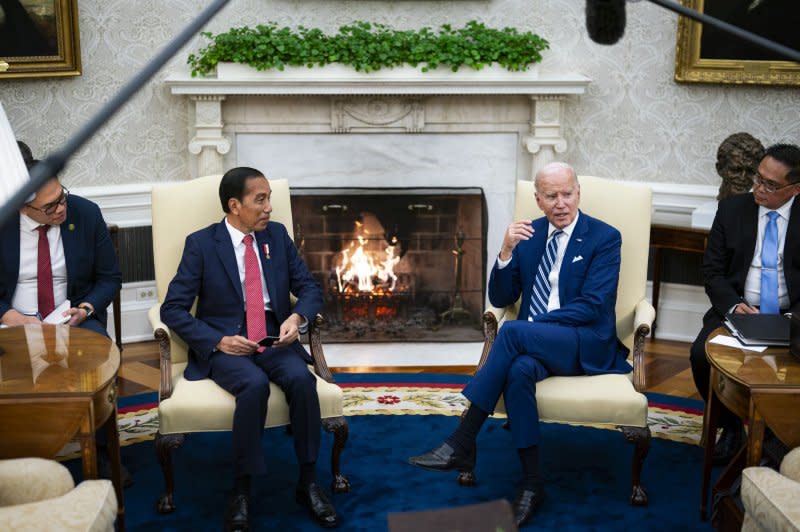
left=0, top=160, right=122, bottom=336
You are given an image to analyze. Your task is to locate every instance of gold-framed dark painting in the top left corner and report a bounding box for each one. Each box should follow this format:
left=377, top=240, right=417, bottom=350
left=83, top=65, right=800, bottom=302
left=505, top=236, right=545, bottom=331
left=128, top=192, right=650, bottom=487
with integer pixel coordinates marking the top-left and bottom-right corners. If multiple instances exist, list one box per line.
left=0, top=0, right=81, bottom=78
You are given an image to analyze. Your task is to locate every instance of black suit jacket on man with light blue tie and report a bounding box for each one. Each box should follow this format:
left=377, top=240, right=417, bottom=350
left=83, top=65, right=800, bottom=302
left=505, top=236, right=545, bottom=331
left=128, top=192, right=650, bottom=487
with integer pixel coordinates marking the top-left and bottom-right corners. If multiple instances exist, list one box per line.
left=703, top=192, right=800, bottom=321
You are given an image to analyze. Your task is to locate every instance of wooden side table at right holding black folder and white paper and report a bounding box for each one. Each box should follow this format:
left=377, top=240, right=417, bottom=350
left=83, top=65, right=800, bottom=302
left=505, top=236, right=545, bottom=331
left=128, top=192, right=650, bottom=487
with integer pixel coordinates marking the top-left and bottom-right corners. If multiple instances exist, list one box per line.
left=700, top=327, right=800, bottom=519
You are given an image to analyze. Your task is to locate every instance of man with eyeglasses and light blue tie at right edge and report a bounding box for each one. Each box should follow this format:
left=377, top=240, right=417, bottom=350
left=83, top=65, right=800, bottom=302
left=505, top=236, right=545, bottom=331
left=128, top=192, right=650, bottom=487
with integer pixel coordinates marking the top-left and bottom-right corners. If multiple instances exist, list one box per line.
left=691, top=144, right=800, bottom=465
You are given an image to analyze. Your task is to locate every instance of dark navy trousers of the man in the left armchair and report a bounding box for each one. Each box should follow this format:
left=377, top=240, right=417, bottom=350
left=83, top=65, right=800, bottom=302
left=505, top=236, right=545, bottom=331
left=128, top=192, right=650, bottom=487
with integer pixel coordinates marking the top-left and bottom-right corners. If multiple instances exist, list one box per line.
left=209, top=313, right=320, bottom=477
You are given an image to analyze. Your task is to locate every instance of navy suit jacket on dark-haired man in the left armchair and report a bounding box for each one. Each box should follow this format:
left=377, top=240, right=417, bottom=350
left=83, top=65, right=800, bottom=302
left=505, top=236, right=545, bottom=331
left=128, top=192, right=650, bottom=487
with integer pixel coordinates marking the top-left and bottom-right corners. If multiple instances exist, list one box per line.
left=161, top=220, right=322, bottom=380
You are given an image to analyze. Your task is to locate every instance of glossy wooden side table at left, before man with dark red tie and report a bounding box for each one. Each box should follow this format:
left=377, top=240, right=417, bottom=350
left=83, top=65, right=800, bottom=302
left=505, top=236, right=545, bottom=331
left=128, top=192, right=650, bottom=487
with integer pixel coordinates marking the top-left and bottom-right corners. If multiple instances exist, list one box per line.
left=0, top=324, right=125, bottom=530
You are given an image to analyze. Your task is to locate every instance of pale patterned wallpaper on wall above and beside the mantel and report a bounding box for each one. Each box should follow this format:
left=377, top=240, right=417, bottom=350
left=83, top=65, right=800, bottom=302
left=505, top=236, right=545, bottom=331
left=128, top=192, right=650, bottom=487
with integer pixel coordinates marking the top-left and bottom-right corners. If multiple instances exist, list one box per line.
left=0, top=0, right=800, bottom=186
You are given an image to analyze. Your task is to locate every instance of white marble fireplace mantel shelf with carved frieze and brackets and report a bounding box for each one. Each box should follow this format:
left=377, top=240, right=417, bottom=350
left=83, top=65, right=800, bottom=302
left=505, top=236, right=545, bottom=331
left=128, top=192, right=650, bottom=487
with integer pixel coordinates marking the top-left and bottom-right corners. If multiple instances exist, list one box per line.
left=165, top=65, right=590, bottom=178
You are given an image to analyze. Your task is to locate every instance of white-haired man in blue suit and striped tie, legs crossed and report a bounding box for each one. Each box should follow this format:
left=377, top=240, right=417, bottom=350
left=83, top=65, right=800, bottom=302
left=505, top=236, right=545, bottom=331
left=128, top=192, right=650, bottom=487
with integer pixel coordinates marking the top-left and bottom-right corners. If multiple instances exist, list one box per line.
left=409, top=163, right=631, bottom=526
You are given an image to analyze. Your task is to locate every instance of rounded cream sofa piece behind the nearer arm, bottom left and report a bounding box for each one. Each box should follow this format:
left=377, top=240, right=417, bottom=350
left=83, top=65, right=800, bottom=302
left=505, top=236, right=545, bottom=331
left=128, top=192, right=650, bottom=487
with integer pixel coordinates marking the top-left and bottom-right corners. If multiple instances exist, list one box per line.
left=0, top=458, right=75, bottom=506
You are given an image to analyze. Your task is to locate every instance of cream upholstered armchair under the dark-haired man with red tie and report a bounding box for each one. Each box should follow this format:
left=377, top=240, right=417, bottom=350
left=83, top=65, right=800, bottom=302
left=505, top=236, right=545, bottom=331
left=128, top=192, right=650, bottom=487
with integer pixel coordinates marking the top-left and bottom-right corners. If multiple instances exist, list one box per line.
left=149, top=175, right=350, bottom=513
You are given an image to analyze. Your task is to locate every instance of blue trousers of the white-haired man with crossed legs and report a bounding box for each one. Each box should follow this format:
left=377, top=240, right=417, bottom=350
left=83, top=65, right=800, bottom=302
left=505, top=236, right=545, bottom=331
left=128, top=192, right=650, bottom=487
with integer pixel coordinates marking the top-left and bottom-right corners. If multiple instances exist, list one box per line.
left=462, top=320, right=583, bottom=449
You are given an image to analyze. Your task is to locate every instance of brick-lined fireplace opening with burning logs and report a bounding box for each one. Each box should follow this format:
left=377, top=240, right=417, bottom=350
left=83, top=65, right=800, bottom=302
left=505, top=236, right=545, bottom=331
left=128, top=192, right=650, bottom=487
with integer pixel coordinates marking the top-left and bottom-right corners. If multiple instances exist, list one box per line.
left=292, top=187, right=487, bottom=342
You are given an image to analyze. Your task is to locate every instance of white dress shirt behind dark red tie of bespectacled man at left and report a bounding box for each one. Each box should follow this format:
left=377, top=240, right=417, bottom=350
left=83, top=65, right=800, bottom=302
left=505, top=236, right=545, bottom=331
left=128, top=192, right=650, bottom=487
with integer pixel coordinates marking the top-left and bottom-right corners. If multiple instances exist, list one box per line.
left=11, top=213, right=67, bottom=318
